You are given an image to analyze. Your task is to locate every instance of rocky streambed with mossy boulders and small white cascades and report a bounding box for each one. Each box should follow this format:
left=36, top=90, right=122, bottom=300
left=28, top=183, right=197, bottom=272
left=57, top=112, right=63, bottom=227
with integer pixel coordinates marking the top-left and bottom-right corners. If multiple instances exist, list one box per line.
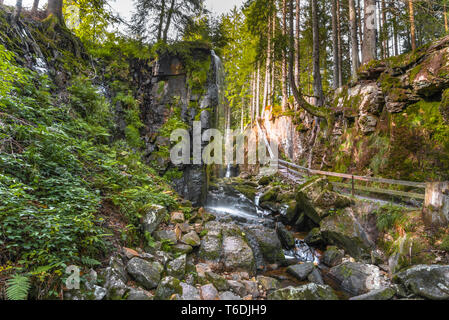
left=65, top=175, right=449, bottom=300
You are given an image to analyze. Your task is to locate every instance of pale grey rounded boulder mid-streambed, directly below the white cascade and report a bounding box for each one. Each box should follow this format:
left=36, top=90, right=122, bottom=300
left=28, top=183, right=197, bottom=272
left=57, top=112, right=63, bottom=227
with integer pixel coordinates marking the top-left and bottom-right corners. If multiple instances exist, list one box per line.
left=223, top=236, right=256, bottom=274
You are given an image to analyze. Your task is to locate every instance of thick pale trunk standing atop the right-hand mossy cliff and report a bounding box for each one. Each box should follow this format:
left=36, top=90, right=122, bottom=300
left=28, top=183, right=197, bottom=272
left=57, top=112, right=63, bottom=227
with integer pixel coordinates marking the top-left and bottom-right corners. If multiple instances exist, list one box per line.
left=362, top=0, right=377, bottom=64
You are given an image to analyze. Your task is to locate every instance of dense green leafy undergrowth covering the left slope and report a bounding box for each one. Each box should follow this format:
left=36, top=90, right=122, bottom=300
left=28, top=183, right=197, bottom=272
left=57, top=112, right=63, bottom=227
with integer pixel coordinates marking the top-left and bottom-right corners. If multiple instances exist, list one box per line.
left=0, top=42, right=178, bottom=298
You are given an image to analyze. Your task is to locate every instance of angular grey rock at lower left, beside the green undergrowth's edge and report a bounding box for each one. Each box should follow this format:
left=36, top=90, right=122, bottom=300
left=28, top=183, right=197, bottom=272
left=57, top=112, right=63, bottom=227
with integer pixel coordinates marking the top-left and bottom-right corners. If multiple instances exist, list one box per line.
left=126, top=258, right=164, bottom=290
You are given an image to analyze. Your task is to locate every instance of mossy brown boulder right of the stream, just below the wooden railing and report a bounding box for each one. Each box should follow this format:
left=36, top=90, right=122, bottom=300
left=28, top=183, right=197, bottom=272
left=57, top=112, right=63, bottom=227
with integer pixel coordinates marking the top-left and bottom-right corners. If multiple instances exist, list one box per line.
left=320, top=208, right=373, bottom=259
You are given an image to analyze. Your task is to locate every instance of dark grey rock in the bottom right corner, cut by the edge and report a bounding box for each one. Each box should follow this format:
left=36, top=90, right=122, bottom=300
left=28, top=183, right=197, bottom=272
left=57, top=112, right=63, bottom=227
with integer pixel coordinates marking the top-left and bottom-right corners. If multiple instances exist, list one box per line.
left=393, top=265, right=449, bottom=300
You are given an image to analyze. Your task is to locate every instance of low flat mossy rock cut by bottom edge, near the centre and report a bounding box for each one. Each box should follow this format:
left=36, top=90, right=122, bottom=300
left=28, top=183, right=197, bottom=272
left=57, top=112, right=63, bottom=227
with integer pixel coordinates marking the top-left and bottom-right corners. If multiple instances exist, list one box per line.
left=268, top=283, right=338, bottom=300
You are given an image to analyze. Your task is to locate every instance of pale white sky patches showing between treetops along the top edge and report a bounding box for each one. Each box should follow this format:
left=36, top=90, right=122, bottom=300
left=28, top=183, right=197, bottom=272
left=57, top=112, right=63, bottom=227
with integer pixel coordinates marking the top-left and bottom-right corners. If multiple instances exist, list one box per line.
left=5, top=0, right=244, bottom=19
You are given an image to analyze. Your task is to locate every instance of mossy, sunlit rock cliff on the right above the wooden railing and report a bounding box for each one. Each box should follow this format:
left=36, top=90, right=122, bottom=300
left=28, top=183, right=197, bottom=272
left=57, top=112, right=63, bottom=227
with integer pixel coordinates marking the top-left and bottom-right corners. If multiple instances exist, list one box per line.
left=265, top=37, right=449, bottom=181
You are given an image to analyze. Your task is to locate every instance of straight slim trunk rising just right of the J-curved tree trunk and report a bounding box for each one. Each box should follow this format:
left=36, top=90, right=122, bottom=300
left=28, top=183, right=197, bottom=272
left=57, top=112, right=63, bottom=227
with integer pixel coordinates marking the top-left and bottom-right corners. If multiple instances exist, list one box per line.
left=311, top=0, right=324, bottom=107
